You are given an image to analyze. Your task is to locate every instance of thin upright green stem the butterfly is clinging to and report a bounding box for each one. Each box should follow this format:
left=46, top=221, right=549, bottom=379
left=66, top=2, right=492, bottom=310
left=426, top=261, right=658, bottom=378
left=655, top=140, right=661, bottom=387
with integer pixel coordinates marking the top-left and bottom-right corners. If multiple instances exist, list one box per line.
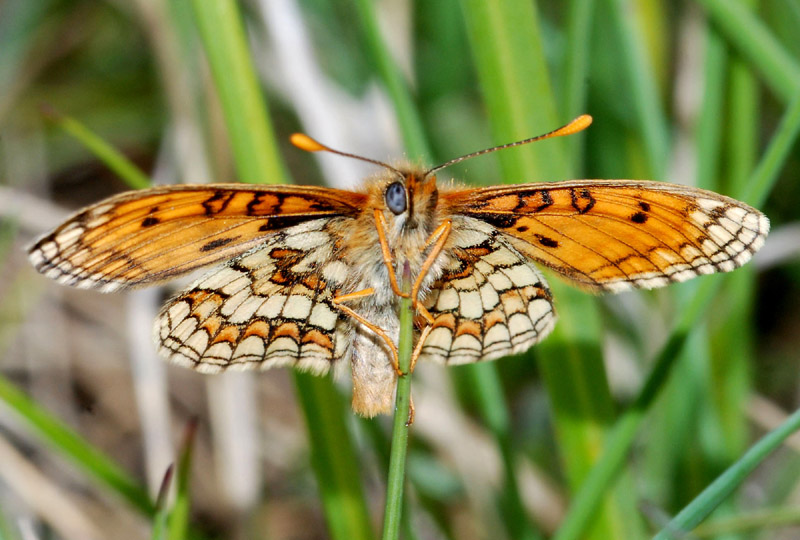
left=383, top=266, right=414, bottom=540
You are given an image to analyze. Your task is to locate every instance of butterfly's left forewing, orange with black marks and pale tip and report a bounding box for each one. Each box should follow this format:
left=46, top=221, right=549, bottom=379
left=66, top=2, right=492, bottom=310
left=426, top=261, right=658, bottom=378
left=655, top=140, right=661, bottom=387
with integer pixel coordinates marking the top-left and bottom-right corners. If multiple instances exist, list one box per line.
left=29, top=184, right=363, bottom=292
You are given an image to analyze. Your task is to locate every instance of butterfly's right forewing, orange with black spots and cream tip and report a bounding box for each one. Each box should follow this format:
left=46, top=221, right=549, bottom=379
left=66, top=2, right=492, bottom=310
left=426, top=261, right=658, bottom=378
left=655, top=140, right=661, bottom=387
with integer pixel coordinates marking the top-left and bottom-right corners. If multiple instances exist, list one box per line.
left=443, top=180, right=769, bottom=292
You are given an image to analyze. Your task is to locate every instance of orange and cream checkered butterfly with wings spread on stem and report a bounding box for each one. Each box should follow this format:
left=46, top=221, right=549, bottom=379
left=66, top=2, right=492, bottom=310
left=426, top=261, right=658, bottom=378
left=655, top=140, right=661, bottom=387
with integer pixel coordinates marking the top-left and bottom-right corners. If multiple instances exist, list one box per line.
left=29, top=115, right=769, bottom=416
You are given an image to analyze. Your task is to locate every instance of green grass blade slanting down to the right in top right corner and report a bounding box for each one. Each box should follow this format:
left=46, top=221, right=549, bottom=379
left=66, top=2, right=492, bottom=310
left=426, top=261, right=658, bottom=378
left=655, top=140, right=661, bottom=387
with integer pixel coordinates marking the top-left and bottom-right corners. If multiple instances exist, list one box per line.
left=697, top=0, right=800, bottom=101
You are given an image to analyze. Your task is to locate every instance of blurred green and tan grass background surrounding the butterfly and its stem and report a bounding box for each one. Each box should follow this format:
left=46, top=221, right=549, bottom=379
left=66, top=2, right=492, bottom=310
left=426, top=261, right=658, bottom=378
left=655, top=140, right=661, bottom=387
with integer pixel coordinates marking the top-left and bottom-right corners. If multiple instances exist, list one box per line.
left=0, top=0, right=800, bottom=540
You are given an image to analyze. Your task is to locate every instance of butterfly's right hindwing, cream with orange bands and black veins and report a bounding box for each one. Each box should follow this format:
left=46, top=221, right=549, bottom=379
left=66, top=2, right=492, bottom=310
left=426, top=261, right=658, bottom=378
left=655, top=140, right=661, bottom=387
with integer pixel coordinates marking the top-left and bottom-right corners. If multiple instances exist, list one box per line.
left=421, top=217, right=555, bottom=365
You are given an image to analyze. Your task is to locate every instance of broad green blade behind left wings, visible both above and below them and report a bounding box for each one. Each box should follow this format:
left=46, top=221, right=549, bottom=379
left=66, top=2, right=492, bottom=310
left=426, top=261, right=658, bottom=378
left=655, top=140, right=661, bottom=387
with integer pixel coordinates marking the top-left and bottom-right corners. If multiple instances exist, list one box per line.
left=193, top=0, right=372, bottom=540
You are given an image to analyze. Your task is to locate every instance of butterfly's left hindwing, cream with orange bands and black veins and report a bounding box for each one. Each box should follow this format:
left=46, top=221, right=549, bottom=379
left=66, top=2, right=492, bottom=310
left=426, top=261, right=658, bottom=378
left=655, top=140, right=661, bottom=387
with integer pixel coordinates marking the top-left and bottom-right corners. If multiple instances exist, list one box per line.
left=155, top=220, right=351, bottom=373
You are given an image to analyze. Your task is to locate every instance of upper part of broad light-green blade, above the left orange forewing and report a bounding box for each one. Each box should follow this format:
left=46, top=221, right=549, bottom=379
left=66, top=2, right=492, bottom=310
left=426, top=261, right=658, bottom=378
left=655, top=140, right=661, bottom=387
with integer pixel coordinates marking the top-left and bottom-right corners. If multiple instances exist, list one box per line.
left=192, top=0, right=285, bottom=184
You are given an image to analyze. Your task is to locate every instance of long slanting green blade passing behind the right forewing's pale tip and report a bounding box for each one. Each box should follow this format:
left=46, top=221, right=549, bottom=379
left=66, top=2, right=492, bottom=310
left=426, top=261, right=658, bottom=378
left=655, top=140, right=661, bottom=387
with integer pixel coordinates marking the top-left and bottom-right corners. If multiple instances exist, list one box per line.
left=554, top=88, right=800, bottom=540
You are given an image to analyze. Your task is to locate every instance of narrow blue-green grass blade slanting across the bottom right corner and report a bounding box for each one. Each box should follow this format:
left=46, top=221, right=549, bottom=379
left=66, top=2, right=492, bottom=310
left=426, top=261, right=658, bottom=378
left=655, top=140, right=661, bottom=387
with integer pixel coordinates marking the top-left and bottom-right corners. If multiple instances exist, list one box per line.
left=655, top=410, right=800, bottom=540
